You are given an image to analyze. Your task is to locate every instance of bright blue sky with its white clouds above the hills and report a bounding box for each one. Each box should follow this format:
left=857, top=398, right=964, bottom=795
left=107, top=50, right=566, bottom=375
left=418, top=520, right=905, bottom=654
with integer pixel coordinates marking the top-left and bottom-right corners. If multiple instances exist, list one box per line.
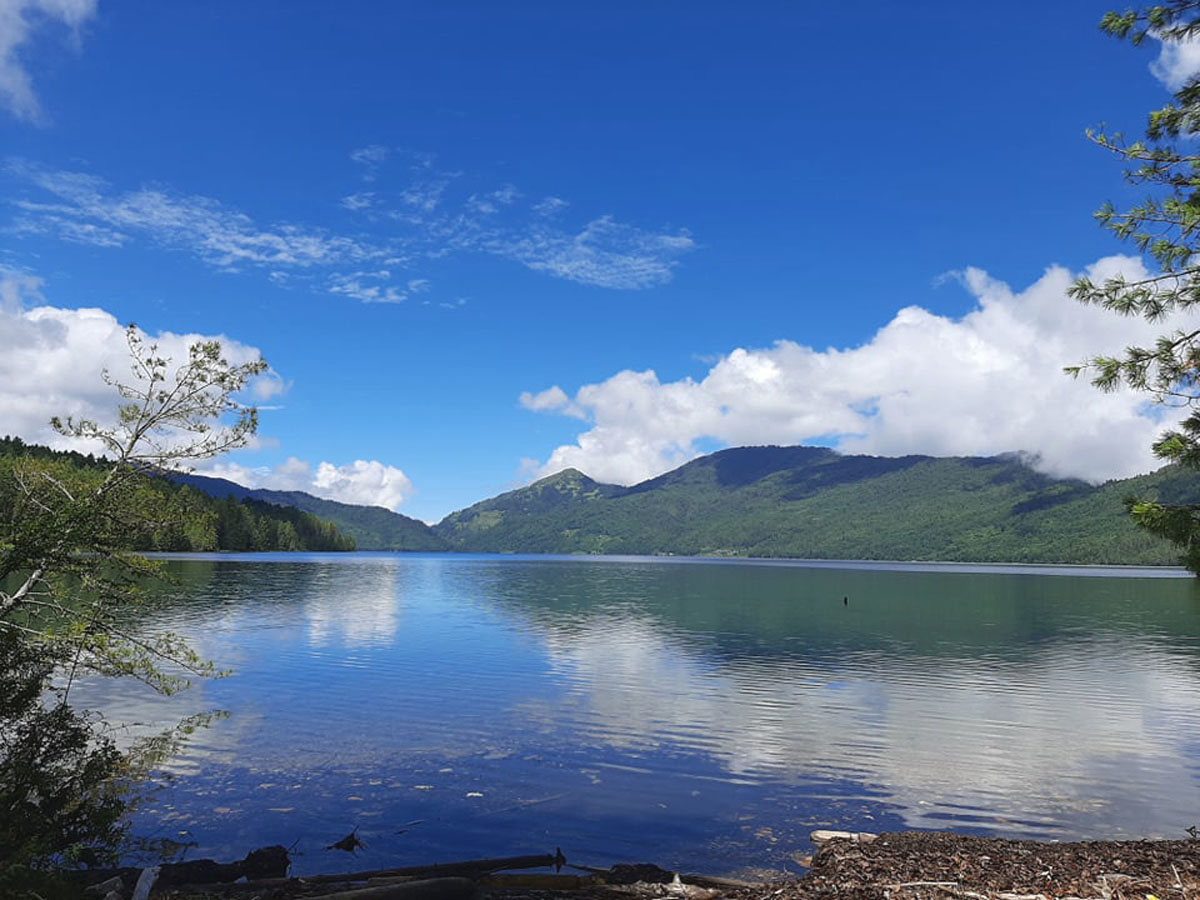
left=0, top=0, right=1189, bottom=520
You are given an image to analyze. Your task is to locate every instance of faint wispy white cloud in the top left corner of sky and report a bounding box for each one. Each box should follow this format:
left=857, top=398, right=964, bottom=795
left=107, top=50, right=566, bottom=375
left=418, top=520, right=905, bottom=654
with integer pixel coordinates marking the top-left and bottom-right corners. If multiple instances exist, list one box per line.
left=0, top=0, right=97, bottom=122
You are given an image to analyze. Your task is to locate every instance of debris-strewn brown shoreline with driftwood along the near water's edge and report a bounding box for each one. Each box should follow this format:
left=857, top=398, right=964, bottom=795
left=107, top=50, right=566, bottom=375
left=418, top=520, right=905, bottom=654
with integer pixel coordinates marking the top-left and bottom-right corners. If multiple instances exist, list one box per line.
left=98, top=832, right=1200, bottom=900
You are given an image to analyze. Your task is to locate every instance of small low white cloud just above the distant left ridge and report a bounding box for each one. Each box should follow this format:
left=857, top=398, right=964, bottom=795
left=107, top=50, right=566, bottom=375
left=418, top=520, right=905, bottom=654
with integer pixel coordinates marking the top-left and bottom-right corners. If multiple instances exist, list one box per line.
left=198, top=456, right=413, bottom=510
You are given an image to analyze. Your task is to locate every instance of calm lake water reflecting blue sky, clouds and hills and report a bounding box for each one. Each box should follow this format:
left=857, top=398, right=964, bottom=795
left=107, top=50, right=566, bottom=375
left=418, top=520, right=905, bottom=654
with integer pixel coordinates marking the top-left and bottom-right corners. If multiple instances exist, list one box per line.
left=79, top=553, right=1200, bottom=874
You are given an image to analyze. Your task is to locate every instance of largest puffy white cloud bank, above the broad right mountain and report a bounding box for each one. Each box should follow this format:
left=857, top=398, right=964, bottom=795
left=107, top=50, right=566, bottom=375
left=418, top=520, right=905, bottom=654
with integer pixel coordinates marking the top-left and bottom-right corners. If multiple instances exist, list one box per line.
left=521, top=257, right=1195, bottom=485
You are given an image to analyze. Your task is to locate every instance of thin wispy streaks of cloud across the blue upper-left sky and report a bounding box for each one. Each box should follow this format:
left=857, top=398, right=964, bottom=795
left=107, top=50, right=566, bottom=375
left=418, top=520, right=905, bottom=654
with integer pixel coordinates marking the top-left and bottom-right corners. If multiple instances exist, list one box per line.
left=9, top=152, right=696, bottom=296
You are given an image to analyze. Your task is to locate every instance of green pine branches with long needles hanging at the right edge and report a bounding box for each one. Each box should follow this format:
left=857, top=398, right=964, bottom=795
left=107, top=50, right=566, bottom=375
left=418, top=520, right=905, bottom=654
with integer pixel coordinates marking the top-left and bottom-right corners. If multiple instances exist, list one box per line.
left=1067, top=0, right=1200, bottom=574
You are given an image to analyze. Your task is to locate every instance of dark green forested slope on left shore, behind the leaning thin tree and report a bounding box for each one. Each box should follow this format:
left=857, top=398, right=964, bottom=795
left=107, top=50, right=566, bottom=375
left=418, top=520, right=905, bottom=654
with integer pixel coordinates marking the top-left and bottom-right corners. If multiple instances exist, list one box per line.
left=0, top=437, right=355, bottom=552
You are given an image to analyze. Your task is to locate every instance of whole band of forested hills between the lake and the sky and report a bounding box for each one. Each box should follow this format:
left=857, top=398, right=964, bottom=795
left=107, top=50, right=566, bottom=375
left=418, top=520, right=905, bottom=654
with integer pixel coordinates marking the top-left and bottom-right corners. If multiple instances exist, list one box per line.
left=11, top=438, right=1200, bottom=565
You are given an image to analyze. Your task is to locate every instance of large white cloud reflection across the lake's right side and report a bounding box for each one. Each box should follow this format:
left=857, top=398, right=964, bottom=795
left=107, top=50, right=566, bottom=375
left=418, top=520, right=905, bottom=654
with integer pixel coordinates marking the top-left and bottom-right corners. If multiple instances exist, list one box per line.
left=530, top=617, right=1200, bottom=836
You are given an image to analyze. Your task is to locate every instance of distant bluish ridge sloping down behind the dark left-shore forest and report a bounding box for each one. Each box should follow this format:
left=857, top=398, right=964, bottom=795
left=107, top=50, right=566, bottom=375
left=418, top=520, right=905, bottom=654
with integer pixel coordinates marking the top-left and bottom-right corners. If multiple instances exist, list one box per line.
left=170, top=474, right=448, bottom=551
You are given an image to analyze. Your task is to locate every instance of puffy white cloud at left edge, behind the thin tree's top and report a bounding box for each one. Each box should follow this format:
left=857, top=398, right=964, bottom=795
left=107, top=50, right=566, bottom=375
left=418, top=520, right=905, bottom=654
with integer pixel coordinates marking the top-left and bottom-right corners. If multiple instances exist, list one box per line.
left=0, top=268, right=276, bottom=452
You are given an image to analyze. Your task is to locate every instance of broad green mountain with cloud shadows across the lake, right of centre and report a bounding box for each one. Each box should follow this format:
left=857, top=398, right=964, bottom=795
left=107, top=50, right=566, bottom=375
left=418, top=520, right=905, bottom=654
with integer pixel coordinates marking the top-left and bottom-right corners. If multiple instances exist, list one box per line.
left=433, top=446, right=1200, bottom=564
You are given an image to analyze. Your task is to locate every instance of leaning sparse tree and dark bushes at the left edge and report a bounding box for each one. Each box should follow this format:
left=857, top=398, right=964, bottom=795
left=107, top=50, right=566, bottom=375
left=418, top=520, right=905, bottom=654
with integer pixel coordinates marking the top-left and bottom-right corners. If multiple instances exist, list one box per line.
left=0, top=326, right=265, bottom=888
